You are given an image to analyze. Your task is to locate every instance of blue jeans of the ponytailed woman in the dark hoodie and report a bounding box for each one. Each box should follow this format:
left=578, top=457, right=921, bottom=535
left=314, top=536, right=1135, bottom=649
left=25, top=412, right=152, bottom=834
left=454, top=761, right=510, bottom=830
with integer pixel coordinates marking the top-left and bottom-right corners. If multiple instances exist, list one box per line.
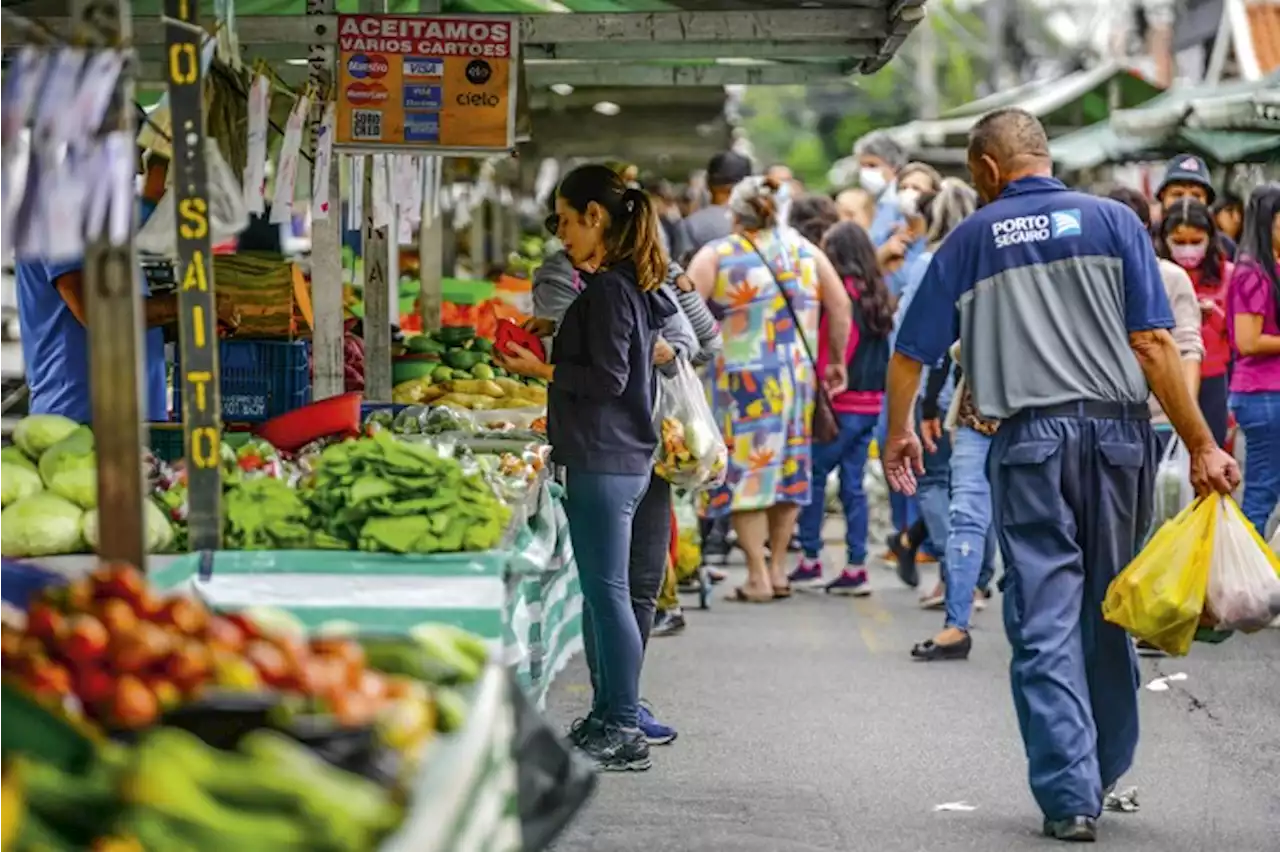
left=564, top=468, right=649, bottom=728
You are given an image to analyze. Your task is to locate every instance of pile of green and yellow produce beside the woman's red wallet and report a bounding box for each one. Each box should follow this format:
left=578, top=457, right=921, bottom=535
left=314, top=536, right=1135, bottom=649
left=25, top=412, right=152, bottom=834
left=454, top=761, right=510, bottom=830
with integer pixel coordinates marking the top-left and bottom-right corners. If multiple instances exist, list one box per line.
left=392, top=326, right=547, bottom=411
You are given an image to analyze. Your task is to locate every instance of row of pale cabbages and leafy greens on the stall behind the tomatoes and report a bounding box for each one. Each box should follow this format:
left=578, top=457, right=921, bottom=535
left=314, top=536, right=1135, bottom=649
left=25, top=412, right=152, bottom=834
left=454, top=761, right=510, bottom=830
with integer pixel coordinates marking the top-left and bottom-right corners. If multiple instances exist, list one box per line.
left=0, top=417, right=512, bottom=558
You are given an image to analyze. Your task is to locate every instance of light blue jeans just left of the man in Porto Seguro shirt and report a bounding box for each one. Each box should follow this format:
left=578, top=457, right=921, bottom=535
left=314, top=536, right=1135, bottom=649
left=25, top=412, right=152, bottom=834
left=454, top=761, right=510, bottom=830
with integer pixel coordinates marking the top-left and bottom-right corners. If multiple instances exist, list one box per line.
left=946, top=426, right=996, bottom=631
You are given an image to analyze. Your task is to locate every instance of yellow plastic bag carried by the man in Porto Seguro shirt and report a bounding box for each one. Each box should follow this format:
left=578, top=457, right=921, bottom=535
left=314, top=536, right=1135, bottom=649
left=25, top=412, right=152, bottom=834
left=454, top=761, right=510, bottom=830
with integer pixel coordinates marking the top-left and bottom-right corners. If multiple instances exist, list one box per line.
left=1102, top=499, right=1219, bottom=656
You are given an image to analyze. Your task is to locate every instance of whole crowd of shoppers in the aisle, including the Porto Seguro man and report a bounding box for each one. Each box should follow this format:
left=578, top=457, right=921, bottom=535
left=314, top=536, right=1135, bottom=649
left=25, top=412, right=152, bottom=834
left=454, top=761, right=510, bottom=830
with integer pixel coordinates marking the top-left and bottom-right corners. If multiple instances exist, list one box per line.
left=517, top=129, right=1280, bottom=808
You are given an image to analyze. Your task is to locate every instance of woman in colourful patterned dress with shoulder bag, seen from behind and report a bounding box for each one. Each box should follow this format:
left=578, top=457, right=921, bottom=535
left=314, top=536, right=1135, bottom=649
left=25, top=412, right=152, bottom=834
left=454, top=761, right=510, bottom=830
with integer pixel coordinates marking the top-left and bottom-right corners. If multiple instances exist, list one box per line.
left=687, top=177, right=852, bottom=603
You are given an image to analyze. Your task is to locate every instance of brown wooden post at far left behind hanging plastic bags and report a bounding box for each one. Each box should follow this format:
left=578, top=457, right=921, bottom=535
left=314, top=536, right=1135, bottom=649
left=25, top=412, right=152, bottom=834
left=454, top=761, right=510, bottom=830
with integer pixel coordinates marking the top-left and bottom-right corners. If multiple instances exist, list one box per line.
left=70, top=0, right=147, bottom=569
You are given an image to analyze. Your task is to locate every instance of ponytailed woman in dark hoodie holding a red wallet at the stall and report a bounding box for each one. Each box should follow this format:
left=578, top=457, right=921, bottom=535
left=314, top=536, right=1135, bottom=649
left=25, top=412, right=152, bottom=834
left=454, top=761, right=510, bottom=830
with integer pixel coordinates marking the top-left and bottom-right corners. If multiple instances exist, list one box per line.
left=502, top=165, right=678, bottom=770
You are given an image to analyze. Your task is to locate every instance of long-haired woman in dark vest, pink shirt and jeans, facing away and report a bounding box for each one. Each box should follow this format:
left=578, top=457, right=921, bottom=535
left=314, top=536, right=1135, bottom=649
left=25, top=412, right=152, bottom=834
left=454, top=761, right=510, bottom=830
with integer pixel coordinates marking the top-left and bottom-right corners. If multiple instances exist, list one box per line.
left=790, top=221, right=893, bottom=595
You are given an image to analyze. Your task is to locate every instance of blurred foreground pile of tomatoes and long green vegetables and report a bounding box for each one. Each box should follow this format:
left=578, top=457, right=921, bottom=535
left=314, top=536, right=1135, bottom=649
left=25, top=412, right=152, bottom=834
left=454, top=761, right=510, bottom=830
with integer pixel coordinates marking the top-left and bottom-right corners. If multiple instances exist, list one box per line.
left=0, top=565, right=486, bottom=852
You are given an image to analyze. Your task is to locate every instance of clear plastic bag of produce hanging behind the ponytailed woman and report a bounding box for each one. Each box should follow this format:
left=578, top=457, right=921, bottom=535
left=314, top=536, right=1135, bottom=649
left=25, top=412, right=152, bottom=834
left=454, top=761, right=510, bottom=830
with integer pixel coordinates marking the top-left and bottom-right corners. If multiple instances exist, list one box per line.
left=653, top=359, right=728, bottom=490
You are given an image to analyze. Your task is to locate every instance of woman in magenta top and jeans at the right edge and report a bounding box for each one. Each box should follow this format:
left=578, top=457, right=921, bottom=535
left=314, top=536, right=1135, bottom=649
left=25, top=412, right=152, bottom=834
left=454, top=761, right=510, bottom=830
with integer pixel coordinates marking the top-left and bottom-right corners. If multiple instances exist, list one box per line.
left=1228, top=183, right=1280, bottom=536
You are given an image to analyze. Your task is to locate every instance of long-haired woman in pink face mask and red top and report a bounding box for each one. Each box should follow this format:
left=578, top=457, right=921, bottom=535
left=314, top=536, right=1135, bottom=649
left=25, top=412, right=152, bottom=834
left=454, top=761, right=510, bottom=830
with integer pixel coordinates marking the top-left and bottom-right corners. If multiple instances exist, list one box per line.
left=1156, top=197, right=1233, bottom=444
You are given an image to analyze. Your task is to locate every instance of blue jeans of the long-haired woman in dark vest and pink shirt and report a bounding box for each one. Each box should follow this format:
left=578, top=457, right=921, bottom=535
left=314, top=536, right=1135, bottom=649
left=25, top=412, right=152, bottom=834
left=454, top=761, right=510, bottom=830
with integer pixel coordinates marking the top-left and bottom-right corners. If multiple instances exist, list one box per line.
left=800, top=414, right=879, bottom=565
